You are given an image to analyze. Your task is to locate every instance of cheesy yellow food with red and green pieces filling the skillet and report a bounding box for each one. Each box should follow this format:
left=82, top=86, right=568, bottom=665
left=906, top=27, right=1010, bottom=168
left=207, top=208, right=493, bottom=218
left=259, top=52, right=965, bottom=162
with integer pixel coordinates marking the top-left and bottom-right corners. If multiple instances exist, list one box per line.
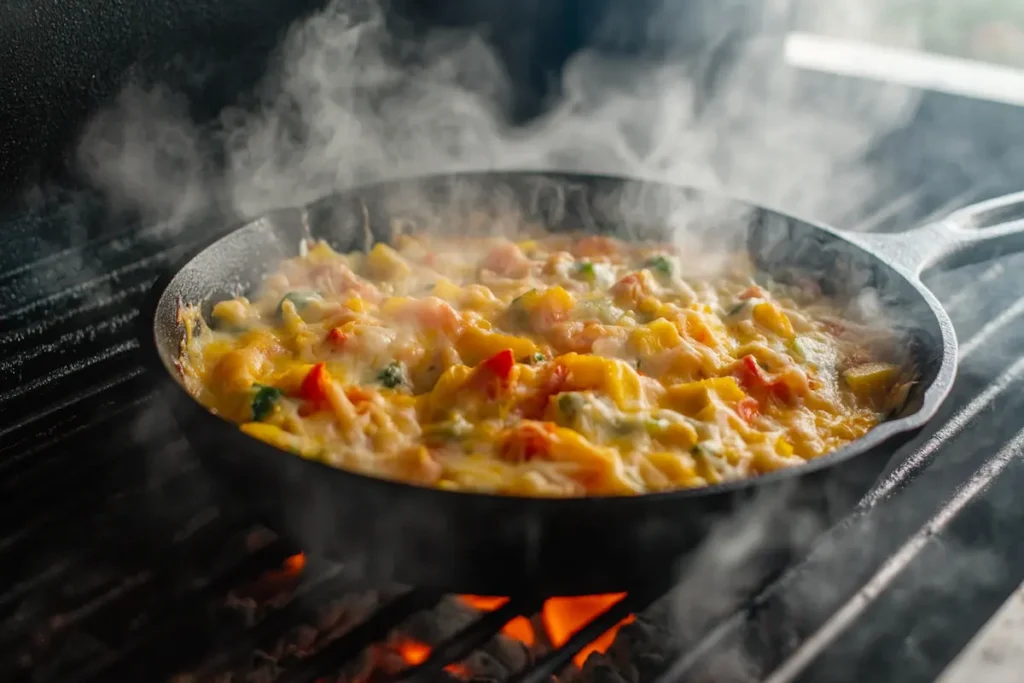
left=180, top=234, right=909, bottom=497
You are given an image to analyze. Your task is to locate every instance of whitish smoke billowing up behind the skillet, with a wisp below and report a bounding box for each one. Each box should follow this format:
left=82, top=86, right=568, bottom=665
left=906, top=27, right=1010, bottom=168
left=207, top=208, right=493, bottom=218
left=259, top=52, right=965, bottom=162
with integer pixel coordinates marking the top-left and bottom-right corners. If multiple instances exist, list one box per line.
left=79, top=0, right=942, bottom=679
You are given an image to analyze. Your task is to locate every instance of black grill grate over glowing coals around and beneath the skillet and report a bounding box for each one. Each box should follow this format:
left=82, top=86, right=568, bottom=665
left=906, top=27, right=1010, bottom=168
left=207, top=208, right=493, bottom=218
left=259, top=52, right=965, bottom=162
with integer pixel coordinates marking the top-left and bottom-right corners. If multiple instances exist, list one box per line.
left=6, top=192, right=1024, bottom=683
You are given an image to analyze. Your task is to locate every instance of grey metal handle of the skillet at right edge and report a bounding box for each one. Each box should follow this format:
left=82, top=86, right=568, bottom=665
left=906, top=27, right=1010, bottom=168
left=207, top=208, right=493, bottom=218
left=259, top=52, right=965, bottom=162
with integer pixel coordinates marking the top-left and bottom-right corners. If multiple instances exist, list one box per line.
left=845, top=188, right=1024, bottom=278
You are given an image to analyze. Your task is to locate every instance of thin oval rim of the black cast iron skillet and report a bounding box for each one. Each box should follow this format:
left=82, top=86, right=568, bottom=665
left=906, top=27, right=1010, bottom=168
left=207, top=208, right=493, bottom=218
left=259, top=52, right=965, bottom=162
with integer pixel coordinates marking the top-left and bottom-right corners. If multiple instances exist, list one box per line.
left=142, top=169, right=957, bottom=513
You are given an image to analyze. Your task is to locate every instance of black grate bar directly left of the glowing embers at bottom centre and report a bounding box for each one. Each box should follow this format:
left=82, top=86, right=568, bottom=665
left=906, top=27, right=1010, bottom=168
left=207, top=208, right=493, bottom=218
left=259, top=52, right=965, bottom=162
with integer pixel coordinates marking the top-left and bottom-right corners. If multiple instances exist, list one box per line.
left=278, top=589, right=442, bottom=683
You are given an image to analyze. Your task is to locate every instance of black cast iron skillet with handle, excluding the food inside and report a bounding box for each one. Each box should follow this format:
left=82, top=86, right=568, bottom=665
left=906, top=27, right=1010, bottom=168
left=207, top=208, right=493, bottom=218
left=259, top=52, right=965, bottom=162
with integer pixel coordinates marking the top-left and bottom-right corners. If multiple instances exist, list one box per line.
left=146, top=172, right=1024, bottom=595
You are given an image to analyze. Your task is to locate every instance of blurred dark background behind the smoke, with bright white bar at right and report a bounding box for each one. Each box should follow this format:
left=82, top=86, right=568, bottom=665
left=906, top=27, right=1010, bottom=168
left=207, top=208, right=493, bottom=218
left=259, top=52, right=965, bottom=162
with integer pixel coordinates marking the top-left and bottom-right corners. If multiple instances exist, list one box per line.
left=0, top=0, right=1024, bottom=219
